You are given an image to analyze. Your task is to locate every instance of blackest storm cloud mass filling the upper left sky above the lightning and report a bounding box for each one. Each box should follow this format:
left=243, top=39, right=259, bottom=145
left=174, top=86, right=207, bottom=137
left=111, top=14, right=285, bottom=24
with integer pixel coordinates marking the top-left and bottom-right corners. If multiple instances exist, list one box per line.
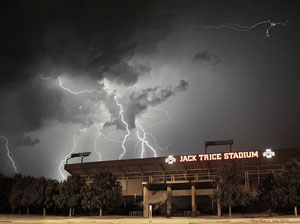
left=0, top=0, right=180, bottom=85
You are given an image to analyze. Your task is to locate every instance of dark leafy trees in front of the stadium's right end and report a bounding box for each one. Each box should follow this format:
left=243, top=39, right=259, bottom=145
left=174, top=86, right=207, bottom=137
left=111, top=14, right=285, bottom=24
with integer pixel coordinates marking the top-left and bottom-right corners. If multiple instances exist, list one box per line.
left=214, top=160, right=300, bottom=216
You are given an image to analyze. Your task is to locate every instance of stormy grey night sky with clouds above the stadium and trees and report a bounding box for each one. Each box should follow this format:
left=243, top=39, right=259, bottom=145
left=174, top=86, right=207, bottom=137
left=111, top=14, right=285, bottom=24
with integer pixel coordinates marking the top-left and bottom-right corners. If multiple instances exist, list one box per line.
left=0, top=0, right=300, bottom=179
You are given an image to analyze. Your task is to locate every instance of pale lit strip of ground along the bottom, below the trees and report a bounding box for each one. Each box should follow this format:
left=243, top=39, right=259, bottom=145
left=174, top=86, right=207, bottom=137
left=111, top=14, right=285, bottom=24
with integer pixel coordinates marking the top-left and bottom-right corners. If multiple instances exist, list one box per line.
left=0, top=215, right=300, bottom=224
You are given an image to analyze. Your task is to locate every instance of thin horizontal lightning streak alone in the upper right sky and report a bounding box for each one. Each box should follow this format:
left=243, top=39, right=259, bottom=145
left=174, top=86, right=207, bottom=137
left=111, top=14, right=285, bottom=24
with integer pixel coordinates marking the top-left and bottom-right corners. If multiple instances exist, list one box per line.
left=192, top=20, right=288, bottom=40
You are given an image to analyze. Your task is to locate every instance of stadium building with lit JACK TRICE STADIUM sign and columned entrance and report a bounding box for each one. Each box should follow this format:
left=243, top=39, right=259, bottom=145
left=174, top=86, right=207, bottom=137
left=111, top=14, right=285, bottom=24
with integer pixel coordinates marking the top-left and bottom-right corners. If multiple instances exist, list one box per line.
left=65, top=149, right=300, bottom=217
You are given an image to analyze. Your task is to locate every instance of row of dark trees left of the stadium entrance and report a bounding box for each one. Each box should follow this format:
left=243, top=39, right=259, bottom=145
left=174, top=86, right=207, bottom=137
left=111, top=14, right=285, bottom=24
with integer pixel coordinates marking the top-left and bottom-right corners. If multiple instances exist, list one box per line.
left=0, top=172, right=122, bottom=216
